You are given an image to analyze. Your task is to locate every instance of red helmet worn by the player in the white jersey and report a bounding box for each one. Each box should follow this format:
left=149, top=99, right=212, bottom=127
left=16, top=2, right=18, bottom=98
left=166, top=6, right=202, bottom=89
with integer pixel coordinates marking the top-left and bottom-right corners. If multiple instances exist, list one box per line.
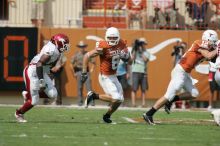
left=51, top=33, right=70, bottom=52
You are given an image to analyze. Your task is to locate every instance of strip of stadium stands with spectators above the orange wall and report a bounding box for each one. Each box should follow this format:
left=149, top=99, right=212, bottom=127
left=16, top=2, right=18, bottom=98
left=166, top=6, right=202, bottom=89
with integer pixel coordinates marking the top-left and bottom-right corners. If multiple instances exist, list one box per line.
left=0, top=0, right=220, bottom=30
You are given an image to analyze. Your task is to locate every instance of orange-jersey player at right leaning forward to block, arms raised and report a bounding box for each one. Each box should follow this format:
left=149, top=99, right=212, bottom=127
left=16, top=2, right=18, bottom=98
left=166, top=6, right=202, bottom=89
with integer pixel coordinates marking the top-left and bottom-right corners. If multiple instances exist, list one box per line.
left=143, top=30, right=218, bottom=125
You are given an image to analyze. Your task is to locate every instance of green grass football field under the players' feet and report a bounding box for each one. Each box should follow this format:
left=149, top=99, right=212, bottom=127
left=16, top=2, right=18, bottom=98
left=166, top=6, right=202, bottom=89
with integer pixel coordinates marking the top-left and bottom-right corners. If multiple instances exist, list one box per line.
left=0, top=107, right=220, bottom=146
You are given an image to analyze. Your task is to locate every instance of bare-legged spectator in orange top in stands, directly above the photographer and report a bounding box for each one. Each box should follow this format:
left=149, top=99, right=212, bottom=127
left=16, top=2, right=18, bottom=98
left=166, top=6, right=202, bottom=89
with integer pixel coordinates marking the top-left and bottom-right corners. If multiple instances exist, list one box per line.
left=126, top=0, right=147, bottom=29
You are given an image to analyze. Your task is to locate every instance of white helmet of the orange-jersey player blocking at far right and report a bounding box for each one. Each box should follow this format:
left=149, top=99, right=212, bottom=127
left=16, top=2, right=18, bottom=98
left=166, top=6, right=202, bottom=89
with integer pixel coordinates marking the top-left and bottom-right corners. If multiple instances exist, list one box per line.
left=202, top=30, right=218, bottom=46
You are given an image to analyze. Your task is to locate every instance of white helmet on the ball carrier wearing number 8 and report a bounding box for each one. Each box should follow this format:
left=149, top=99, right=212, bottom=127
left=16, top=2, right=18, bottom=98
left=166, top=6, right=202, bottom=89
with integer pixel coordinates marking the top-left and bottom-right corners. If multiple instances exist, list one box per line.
left=105, top=27, right=120, bottom=46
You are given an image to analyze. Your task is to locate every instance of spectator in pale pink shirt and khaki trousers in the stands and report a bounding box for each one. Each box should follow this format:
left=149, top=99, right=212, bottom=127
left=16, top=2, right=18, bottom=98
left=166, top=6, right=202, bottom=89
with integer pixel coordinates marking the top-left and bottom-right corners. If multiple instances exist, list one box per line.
left=153, top=0, right=177, bottom=29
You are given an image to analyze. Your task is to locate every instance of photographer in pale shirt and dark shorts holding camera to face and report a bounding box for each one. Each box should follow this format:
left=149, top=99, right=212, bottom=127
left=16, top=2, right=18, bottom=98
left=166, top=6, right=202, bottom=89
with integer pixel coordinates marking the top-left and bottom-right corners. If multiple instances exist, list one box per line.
left=131, top=38, right=150, bottom=107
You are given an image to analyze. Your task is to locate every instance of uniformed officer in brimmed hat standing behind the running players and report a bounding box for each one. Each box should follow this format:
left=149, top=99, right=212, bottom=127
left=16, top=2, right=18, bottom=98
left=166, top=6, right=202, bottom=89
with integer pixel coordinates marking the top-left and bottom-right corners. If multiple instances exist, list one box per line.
left=70, top=41, right=95, bottom=106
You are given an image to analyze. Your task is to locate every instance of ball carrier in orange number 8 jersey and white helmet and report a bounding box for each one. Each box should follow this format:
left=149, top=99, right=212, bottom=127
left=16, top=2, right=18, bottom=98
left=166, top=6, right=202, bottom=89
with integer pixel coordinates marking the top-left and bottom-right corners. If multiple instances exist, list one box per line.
left=81, top=27, right=130, bottom=123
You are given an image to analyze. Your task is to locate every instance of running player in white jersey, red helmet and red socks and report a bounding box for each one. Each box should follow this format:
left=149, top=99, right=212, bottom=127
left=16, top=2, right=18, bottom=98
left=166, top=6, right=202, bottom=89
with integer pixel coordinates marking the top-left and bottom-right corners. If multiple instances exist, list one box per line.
left=15, top=34, right=69, bottom=122
